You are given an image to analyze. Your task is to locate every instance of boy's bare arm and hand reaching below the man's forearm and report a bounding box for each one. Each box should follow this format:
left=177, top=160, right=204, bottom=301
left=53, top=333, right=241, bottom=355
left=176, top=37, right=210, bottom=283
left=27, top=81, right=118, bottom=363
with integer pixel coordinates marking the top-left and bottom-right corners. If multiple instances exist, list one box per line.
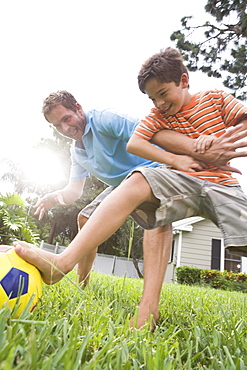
left=126, top=133, right=207, bottom=172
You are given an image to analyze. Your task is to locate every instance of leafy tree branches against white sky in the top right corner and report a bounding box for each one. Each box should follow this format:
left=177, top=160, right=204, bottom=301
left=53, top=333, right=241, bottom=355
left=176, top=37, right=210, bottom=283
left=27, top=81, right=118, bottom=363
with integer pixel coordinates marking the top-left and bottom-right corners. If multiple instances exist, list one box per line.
left=170, top=0, right=247, bottom=100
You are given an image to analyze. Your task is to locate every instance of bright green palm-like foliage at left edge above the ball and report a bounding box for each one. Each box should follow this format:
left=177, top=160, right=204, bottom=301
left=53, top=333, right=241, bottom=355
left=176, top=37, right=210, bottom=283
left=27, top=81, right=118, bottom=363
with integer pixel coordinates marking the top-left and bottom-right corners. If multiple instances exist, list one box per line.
left=0, top=193, right=40, bottom=245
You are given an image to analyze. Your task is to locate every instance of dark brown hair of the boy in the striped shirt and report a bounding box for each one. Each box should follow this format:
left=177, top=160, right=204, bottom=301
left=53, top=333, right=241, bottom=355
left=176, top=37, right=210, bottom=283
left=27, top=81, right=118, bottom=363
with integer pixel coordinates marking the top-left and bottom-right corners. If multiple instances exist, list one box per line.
left=138, top=48, right=188, bottom=94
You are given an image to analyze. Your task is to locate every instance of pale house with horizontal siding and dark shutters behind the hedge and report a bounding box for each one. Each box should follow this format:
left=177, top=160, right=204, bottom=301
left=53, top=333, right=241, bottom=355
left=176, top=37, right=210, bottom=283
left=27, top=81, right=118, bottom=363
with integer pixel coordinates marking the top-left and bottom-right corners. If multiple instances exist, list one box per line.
left=164, top=217, right=244, bottom=282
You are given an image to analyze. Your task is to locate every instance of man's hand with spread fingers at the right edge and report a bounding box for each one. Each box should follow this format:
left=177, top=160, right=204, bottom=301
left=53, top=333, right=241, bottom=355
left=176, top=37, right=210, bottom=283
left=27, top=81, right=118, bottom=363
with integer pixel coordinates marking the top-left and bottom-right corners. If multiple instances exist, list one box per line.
left=195, top=124, right=247, bottom=174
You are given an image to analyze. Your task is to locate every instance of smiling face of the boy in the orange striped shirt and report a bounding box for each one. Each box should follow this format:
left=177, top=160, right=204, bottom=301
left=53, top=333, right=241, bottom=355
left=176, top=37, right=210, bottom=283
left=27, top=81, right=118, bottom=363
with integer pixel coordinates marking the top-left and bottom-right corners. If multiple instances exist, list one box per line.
left=145, top=73, right=191, bottom=116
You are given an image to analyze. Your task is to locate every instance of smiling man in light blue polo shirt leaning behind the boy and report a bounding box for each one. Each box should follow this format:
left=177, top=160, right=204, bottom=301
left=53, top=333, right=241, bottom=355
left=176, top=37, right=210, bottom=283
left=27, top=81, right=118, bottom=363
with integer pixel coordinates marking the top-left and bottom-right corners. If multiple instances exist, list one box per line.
left=35, top=91, right=247, bottom=328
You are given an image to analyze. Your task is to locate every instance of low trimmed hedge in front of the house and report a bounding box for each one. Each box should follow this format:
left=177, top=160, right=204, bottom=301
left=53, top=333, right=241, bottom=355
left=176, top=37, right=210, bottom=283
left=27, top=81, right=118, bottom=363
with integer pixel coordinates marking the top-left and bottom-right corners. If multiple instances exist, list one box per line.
left=176, top=266, right=247, bottom=293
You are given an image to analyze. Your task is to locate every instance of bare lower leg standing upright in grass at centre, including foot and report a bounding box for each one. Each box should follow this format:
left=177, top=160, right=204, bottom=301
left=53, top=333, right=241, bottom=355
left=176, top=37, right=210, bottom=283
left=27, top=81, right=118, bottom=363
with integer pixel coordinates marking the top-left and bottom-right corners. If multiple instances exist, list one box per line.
left=130, top=225, right=172, bottom=329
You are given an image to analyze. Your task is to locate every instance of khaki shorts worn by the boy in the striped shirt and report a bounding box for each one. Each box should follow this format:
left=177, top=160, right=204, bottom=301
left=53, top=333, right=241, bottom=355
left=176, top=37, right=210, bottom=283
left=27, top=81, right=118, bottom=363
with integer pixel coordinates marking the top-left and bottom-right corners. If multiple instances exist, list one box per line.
left=128, top=166, right=247, bottom=256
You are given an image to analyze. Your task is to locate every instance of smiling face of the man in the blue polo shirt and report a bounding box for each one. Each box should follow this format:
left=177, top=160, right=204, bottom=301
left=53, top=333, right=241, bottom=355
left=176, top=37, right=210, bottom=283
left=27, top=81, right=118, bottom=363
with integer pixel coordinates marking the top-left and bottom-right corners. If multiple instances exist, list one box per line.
left=46, top=104, right=86, bottom=140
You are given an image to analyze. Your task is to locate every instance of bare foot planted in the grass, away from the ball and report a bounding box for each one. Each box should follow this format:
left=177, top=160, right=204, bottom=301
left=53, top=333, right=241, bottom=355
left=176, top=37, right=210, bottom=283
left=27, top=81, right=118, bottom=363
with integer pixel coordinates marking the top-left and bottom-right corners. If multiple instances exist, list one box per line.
left=130, top=303, right=159, bottom=331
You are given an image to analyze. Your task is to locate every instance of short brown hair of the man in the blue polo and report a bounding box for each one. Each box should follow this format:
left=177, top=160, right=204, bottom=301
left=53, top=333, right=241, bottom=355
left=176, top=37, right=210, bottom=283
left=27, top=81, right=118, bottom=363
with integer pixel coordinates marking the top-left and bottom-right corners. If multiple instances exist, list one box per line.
left=42, top=90, right=77, bottom=121
